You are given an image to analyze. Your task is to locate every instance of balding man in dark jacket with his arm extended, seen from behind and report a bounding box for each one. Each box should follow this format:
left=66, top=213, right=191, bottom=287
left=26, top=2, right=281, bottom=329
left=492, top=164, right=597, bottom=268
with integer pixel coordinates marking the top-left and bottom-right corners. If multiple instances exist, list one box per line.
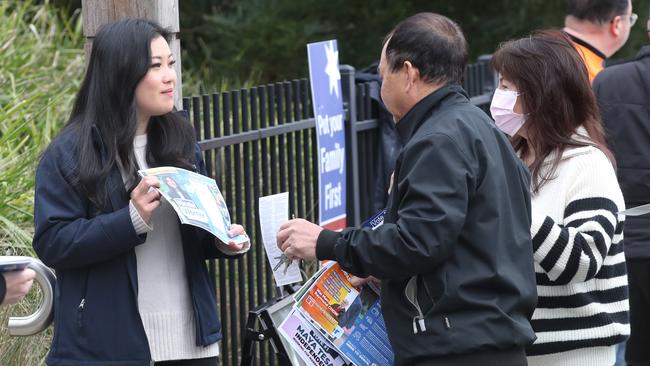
left=277, top=13, right=537, bottom=366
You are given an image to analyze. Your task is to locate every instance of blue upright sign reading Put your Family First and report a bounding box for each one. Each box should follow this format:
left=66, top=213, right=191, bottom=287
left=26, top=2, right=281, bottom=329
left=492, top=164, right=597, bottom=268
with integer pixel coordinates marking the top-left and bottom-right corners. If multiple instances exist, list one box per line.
left=307, top=40, right=346, bottom=230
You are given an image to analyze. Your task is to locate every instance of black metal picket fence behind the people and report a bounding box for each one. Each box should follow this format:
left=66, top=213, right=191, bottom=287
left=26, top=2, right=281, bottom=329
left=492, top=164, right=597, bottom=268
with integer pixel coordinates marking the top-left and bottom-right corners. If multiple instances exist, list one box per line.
left=183, top=58, right=495, bottom=366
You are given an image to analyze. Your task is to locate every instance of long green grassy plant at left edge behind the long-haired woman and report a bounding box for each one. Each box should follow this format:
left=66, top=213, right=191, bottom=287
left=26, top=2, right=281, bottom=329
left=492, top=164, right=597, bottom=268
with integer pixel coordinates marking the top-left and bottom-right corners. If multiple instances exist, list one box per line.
left=0, top=0, right=84, bottom=365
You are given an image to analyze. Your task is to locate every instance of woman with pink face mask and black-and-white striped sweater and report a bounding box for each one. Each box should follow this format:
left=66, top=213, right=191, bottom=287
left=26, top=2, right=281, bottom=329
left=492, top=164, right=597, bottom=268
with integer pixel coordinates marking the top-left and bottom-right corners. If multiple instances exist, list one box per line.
left=490, top=31, right=629, bottom=366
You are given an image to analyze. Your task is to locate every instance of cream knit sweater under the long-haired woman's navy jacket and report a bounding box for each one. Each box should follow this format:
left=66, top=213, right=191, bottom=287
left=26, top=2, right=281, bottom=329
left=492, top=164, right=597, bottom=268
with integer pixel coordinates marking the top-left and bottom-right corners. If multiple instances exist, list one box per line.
left=126, top=135, right=219, bottom=361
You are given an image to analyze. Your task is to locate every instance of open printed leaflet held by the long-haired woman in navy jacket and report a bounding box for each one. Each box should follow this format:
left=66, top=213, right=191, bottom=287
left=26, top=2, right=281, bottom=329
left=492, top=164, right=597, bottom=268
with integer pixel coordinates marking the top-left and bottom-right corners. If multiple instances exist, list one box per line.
left=138, top=167, right=249, bottom=244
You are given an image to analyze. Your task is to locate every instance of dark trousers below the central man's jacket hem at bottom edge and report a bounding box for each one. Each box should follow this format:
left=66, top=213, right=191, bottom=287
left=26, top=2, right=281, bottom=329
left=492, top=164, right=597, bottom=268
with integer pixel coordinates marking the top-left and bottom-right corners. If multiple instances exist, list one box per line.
left=409, top=347, right=528, bottom=366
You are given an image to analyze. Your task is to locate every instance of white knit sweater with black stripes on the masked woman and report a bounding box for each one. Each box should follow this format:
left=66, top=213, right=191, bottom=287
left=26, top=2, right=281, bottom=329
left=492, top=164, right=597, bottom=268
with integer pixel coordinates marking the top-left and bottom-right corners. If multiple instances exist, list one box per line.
left=527, top=146, right=630, bottom=366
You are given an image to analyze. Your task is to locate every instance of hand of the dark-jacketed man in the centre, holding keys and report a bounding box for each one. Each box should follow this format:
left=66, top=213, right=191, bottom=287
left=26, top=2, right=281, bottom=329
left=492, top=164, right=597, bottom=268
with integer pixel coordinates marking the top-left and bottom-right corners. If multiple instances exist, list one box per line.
left=277, top=219, right=323, bottom=260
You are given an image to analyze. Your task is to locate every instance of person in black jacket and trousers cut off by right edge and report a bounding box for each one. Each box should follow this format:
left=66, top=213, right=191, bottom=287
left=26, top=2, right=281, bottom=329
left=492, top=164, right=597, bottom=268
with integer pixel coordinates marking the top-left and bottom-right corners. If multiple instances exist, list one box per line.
left=593, top=5, right=650, bottom=366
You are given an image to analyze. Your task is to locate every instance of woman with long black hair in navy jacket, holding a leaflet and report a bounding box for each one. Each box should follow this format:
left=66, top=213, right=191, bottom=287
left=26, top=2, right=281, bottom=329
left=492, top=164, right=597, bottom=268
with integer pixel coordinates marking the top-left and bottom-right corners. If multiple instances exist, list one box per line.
left=33, top=19, right=250, bottom=366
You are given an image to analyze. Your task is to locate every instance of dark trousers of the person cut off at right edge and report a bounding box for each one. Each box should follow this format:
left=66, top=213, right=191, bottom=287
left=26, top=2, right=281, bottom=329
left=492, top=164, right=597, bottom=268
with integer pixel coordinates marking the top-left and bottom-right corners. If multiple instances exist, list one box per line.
left=625, top=258, right=650, bottom=366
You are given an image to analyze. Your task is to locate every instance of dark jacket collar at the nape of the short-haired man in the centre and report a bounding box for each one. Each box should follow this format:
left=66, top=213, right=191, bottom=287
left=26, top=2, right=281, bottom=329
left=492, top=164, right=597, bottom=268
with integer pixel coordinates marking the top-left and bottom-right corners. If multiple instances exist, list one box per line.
left=396, top=84, right=469, bottom=144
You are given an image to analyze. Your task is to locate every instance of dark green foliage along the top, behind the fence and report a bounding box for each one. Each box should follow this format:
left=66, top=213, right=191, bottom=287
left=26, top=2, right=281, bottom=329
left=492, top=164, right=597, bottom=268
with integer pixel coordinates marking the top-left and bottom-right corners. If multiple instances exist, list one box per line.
left=180, top=0, right=650, bottom=94
